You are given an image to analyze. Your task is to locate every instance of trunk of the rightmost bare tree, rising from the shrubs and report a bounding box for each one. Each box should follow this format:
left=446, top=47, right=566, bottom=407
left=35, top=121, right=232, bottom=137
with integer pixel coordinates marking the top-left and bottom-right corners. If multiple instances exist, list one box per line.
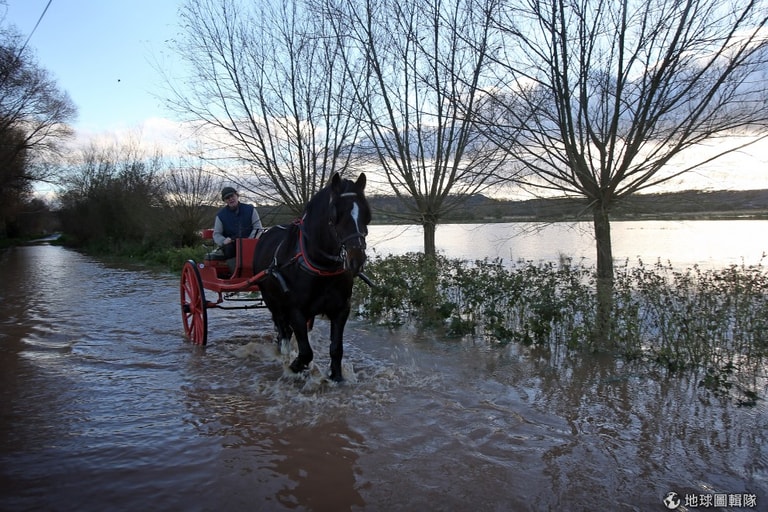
left=592, top=204, right=613, bottom=350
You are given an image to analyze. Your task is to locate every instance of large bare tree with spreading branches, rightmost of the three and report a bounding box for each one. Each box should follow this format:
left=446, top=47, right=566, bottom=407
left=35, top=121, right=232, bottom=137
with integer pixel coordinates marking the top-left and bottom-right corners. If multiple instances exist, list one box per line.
left=487, top=0, right=768, bottom=344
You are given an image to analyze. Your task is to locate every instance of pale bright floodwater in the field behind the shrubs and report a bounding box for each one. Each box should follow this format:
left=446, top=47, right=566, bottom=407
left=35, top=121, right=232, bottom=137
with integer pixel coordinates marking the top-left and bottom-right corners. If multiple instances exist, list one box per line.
left=368, top=219, right=768, bottom=269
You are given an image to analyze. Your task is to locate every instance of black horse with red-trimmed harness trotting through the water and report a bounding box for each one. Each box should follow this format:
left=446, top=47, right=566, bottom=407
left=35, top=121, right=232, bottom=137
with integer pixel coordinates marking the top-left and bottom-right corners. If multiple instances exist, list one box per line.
left=253, top=173, right=371, bottom=382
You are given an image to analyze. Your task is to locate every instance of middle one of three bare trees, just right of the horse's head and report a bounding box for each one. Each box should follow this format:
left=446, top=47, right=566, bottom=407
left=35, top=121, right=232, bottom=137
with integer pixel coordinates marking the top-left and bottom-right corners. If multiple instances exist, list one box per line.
left=327, top=0, right=506, bottom=255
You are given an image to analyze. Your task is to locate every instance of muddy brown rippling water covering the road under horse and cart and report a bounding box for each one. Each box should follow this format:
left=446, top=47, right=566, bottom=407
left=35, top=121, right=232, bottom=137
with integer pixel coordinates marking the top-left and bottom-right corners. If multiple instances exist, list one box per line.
left=0, top=245, right=768, bottom=511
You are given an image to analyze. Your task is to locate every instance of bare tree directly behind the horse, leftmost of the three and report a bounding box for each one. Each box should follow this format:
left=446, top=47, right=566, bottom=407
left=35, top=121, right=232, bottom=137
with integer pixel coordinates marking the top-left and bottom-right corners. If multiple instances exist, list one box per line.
left=169, top=0, right=359, bottom=213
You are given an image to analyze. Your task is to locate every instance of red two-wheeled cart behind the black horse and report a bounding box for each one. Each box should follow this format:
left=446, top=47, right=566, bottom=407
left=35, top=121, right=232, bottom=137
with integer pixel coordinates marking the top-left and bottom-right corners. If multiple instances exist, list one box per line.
left=180, top=229, right=266, bottom=345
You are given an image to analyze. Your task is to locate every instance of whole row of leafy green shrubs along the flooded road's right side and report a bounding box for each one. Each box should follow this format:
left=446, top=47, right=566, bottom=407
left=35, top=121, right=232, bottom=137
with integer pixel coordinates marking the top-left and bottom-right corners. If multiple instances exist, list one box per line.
left=354, top=253, right=768, bottom=404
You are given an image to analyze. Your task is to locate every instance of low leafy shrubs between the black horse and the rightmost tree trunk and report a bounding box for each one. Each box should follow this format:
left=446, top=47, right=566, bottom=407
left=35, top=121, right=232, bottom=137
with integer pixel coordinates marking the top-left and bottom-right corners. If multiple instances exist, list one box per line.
left=354, top=253, right=594, bottom=347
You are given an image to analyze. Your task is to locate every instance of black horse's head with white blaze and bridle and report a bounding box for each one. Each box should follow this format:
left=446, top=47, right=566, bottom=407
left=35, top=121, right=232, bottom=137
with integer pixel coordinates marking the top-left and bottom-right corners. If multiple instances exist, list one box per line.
left=329, top=173, right=371, bottom=276
